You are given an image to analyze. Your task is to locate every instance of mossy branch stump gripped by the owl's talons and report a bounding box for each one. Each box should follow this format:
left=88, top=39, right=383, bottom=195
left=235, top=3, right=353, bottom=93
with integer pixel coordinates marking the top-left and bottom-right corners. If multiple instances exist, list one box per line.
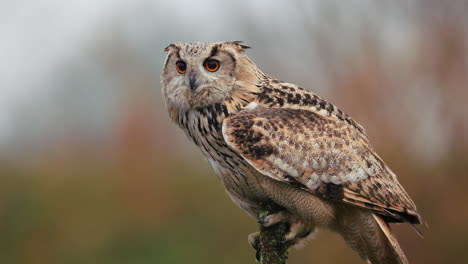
left=258, top=202, right=290, bottom=264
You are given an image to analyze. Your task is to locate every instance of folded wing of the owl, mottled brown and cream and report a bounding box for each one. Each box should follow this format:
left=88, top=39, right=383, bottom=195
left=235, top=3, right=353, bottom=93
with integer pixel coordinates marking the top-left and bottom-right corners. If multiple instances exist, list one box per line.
left=222, top=106, right=420, bottom=223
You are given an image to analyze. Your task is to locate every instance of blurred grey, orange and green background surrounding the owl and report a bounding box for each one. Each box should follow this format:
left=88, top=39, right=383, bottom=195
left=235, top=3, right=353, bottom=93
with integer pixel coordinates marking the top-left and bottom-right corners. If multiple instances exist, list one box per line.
left=0, top=0, right=468, bottom=264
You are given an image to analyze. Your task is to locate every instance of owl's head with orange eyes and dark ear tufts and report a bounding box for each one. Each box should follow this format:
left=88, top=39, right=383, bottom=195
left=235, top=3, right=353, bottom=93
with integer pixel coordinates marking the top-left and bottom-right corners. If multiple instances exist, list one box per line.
left=161, top=41, right=260, bottom=111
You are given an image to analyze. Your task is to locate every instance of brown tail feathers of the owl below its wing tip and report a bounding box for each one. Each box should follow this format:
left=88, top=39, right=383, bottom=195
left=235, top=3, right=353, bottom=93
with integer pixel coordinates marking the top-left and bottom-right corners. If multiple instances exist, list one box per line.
left=341, top=210, right=409, bottom=264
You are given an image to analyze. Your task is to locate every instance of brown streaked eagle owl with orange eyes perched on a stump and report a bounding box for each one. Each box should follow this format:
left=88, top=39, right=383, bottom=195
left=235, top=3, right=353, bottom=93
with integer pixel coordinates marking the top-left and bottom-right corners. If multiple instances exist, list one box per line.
left=161, top=41, right=422, bottom=263
